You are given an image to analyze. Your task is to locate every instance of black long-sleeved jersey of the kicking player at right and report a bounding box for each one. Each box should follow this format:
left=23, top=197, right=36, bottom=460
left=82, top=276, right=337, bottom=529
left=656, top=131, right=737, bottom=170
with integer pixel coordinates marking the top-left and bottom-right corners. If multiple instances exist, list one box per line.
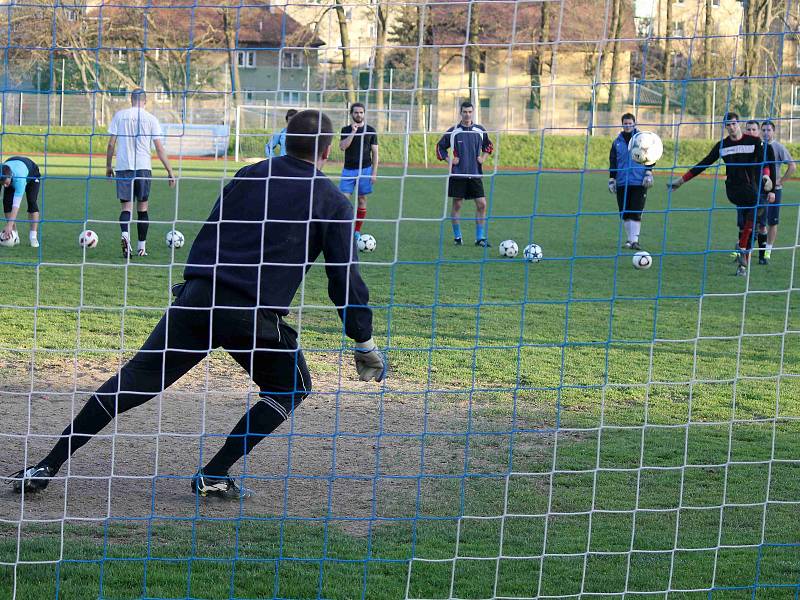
left=683, top=135, right=775, bottom=194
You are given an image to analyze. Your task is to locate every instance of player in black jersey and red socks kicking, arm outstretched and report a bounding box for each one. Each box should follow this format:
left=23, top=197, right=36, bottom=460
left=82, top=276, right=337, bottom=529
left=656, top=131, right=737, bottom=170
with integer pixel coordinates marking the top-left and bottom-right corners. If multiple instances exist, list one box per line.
left=669, top=113, right=775, bottom=276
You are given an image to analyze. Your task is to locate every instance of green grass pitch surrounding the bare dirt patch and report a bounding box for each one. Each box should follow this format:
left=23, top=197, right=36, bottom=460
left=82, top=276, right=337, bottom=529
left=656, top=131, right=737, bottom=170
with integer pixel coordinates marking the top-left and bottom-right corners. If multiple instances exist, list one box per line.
left=0, top=157, right=800, bottom=600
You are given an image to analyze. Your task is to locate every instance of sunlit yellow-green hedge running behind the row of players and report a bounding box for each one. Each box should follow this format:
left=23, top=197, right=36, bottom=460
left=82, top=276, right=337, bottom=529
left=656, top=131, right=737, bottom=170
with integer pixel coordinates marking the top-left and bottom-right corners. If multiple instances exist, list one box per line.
left=0, top=126, right=800, bottom=170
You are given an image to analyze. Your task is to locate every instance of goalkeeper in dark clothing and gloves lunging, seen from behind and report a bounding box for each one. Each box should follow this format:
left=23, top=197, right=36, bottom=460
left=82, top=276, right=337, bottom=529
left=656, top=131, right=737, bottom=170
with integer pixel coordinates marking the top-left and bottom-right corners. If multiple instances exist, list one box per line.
left=11, top=110, right=386, bottom=499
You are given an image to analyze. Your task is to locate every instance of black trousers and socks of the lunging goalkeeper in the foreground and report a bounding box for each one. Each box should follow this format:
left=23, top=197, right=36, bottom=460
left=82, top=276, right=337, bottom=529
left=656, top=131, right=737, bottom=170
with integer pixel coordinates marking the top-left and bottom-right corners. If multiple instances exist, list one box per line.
left=39, top=279, right=311, bottom=475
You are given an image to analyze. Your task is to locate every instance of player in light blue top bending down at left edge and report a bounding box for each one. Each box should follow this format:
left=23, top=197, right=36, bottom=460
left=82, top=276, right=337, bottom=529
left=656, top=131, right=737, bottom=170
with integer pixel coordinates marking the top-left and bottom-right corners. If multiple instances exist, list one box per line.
left=0, top=156, right=41, bottom=248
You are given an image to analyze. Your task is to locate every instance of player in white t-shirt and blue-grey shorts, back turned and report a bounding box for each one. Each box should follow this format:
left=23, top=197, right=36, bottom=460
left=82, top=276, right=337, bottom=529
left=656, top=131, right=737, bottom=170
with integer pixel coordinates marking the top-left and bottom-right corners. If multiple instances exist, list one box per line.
left=106, top=88, right=175, bottom=258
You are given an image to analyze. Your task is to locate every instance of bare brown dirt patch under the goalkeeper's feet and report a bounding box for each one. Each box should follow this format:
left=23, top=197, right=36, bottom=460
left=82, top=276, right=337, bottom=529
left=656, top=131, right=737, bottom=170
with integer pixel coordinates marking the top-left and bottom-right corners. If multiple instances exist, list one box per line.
left=0, top=354, right=553, bottom=532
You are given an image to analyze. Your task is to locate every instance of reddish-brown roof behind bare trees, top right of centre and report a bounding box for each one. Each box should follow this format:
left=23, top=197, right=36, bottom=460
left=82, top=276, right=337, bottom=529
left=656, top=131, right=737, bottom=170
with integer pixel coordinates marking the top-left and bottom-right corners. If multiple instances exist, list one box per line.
left=430, top=0, right=636, bottom=49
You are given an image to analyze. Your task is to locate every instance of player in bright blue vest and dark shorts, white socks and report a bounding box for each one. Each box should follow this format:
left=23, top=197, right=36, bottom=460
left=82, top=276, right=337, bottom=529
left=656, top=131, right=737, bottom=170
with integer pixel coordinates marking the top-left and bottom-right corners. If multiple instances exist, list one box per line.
left=608, top=113, right=653, bottom=250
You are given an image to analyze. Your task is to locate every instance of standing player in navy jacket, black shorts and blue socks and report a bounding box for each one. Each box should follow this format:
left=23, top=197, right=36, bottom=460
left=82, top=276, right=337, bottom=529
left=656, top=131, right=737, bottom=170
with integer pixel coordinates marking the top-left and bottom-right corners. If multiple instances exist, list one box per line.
left=436, top=101, right=494, bottom=248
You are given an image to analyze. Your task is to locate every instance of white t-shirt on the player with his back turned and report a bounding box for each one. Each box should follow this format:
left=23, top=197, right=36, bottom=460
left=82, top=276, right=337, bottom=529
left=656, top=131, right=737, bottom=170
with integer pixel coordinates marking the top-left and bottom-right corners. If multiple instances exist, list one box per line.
left=108, top=106, right=161, bottom=171
